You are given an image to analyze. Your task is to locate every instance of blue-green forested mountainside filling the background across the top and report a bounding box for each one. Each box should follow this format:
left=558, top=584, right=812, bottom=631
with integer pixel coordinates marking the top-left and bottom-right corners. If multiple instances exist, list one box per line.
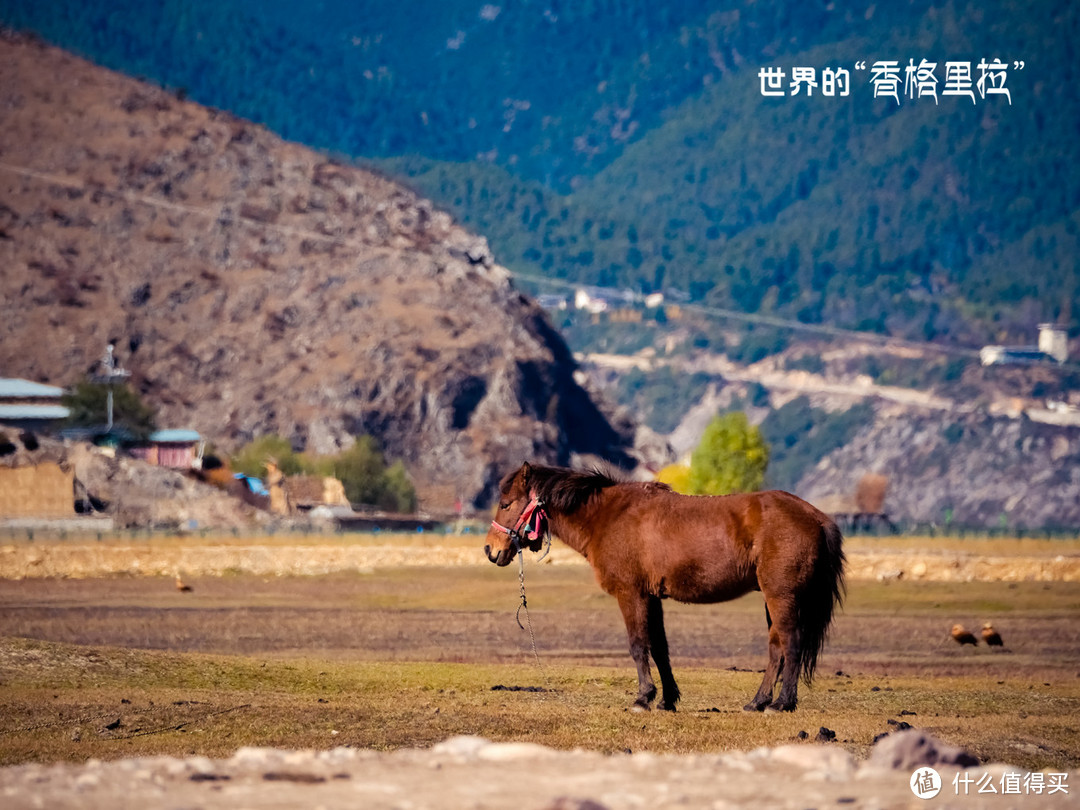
left=0, top=0, right=1080, bottom=346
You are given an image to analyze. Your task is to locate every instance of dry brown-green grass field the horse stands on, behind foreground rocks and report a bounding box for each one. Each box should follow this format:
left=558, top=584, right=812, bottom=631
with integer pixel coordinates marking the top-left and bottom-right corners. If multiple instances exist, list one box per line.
left=0, top=536, right=1080, bottom=769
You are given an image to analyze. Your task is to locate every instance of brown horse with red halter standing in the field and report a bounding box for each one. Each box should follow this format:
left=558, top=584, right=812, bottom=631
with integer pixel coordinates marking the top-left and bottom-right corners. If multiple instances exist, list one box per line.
left=484, top=463, right=845, bottom=712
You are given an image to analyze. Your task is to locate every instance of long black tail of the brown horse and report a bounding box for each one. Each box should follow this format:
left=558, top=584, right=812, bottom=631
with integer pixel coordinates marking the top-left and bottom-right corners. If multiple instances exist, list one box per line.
left=798, top=518, right=846, bottom=685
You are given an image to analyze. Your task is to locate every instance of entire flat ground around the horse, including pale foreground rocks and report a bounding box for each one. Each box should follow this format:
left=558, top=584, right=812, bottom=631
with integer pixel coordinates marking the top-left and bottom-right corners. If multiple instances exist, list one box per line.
left=0, top=537, right=1080, bottom=810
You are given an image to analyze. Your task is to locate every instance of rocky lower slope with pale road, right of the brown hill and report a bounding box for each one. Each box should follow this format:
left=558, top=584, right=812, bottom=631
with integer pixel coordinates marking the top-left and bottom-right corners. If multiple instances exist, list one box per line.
left=582, top=341, right=1080, bottom=531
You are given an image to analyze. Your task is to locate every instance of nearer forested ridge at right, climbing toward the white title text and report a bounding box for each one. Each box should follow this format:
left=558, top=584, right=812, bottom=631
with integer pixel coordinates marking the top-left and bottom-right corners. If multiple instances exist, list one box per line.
left=390, top=3, right=1080, bottom=348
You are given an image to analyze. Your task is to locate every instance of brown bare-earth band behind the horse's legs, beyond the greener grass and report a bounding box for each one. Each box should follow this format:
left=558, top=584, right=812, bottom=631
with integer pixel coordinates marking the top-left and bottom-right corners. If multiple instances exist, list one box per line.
left=0, top=563, right=1080, bottom=684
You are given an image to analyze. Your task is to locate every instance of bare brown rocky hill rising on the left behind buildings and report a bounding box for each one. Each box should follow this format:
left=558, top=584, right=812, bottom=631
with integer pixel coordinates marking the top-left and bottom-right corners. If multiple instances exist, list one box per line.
left=0, top=37, right=632, bottom=509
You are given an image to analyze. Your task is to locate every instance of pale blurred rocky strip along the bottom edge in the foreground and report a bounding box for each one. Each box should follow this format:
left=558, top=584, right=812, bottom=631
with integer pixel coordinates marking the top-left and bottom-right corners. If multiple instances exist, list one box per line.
left=0, top=735, right=1080, bottom=810
